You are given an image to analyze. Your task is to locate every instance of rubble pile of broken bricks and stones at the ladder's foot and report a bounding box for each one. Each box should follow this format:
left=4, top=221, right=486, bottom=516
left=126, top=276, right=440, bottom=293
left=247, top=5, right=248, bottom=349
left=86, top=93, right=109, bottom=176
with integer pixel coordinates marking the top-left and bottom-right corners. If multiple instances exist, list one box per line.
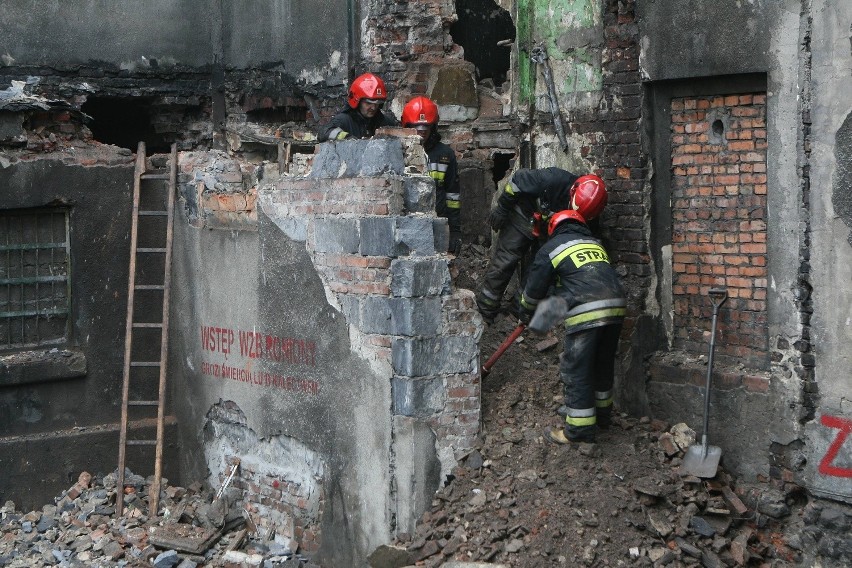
left=0, top=470, right=310, bottom=568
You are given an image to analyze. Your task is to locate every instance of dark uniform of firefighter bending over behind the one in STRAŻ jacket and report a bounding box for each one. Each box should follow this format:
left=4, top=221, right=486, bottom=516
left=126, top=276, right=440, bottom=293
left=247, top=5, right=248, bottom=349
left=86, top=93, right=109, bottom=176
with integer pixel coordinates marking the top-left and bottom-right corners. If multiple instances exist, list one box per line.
left=476, top=168, right=603, bottom=322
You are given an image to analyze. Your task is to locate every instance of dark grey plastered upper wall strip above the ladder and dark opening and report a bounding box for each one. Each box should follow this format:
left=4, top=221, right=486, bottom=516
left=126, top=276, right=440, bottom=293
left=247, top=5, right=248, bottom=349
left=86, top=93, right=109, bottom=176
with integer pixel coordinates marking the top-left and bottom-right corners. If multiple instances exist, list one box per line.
left=0, top=0, right=349, bottom=82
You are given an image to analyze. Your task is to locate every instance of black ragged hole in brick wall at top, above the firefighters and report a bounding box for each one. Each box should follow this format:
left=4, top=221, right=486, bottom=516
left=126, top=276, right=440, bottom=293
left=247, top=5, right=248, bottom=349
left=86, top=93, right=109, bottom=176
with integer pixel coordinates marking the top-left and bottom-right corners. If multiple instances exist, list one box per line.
left=450, top=0, right=515, bottom=87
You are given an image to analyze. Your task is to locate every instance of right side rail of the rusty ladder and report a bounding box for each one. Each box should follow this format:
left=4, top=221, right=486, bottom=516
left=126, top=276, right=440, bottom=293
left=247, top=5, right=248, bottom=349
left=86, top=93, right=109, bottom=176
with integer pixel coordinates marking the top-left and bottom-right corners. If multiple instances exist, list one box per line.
left=148, top=144, right=177, bottom=517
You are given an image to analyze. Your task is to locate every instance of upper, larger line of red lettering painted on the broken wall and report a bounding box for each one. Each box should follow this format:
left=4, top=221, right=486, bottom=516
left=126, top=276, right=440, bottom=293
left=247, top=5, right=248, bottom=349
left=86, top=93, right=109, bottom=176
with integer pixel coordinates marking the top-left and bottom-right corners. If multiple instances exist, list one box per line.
left=201, top=325, right=317, bottom=367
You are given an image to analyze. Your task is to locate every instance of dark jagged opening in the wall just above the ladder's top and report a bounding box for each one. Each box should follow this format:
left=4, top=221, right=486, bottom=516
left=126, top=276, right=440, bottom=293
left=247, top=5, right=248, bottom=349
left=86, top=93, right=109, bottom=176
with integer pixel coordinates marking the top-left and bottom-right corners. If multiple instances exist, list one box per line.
left=81, top=97, right=170, bottom=154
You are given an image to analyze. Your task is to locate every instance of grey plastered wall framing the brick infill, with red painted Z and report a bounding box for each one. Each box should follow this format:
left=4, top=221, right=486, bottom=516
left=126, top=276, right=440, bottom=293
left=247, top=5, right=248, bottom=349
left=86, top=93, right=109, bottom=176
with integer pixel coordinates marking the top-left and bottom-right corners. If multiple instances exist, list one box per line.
left=637, top=1, right=852, bottom=500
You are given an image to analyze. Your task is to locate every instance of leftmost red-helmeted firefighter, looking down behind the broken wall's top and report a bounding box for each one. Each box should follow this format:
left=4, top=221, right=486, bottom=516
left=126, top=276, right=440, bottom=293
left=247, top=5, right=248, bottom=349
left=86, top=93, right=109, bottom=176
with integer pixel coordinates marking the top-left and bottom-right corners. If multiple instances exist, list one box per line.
left=317, top=73, right=399, bottom=142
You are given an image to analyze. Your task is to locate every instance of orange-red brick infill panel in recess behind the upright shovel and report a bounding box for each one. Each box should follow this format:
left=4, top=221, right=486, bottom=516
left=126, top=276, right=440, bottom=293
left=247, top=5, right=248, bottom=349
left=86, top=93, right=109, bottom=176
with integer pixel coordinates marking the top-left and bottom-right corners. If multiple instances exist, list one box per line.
left=671, top=93, right=769, bottom=369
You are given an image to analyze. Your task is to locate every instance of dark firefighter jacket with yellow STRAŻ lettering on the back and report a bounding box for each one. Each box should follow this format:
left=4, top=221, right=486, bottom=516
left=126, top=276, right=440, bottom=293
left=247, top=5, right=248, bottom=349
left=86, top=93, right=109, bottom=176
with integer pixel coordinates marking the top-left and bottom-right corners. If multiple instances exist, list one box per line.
left=521, top=220, right=627, bottom=333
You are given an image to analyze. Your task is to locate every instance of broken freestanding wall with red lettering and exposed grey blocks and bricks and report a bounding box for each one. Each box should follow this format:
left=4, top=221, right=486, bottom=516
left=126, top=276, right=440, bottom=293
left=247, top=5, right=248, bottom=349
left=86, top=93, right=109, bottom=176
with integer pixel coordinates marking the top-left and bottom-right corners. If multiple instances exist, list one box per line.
left=170, top=139, right=482, bottom=566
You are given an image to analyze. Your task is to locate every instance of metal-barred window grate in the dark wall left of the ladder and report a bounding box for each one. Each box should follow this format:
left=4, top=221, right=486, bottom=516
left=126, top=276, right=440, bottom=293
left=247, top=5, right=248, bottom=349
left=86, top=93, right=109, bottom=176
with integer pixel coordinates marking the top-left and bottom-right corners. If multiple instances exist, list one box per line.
left=0, top=208, right=71, bottom=350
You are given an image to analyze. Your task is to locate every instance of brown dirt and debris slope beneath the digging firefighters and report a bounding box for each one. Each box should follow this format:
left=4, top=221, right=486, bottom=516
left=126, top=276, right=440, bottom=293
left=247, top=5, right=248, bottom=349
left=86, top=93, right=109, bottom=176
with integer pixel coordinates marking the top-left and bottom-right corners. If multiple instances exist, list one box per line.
left=390, top=246, right=852, bottom=568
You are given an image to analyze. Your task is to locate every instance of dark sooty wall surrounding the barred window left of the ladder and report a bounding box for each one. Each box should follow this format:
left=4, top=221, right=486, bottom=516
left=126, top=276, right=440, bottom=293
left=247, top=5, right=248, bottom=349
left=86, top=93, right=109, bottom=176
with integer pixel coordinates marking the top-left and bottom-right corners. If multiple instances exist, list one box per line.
left=0, top=154, right=177, bottom=508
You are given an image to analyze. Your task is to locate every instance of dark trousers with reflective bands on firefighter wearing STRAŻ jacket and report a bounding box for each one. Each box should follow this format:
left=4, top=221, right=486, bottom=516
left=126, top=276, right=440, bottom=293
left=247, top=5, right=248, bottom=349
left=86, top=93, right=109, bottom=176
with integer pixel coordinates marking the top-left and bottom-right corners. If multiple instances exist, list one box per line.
left=559, top=322, right=622, bottom=441
